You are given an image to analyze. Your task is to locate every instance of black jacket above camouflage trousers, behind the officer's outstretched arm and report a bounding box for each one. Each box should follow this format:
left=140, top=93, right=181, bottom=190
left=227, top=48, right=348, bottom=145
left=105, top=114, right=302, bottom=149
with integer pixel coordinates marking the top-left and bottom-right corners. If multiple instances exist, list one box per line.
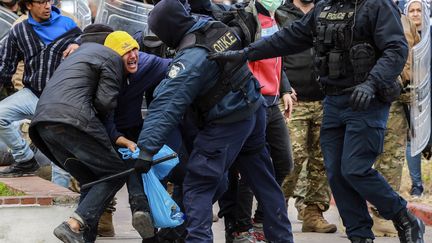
left=276, top=1, right=324, bottom=101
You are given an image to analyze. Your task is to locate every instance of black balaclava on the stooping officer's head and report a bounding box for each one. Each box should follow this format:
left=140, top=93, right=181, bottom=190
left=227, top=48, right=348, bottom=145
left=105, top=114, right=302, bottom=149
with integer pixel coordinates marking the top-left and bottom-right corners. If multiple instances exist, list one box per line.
left=148, top=0, right=196, bottom=48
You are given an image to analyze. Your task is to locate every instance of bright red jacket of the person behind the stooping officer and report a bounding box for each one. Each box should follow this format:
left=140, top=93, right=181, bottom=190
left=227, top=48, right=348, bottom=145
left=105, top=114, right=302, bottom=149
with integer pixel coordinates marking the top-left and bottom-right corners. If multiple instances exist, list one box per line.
left=248, top=14, right=282, bottom=96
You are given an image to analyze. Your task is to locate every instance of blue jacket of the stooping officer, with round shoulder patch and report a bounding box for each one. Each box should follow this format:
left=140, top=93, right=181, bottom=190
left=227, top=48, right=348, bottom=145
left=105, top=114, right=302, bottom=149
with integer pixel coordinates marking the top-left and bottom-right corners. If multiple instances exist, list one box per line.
left=137, top=21, right=264, bottom=159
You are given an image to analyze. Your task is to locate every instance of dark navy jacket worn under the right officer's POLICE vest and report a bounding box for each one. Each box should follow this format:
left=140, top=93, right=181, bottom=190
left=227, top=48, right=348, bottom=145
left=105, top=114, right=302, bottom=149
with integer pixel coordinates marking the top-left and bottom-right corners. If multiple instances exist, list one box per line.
left=248, top=0, right=408, bottom=90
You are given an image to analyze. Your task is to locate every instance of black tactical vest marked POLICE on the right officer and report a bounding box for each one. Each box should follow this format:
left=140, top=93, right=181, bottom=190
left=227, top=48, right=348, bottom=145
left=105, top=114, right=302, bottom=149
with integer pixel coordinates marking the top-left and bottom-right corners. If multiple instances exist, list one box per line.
left=314, top=0, right=377, bottom=86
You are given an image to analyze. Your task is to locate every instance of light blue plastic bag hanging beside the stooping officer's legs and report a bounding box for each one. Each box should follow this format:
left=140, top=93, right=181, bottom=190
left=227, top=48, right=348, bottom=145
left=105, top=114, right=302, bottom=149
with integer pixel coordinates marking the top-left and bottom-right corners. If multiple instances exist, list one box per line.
left=142, top=168, right=184, bottom=228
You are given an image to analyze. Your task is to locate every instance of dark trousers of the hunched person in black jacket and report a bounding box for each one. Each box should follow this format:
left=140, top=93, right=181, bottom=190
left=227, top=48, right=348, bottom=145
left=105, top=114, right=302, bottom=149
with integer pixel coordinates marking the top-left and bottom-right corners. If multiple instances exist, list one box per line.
left=36, top=123, right=127, bottom=242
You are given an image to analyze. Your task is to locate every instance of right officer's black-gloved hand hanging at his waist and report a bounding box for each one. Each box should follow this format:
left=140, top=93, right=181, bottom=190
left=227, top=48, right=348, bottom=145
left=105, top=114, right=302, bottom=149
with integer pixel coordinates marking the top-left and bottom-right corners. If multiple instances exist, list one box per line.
left=350, top=80, right=376, bottom=111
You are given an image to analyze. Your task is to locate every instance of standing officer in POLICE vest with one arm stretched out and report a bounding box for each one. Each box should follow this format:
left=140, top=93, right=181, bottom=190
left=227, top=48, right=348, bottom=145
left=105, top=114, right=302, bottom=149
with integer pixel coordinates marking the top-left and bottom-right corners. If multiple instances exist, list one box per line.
left=209, top=0, right=424, bottom=243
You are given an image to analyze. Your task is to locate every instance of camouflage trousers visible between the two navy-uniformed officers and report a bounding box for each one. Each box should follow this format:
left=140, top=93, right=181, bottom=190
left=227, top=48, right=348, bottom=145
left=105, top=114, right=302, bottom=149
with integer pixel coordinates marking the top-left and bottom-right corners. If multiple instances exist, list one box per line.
left=282, top=101, right=330, bottom=211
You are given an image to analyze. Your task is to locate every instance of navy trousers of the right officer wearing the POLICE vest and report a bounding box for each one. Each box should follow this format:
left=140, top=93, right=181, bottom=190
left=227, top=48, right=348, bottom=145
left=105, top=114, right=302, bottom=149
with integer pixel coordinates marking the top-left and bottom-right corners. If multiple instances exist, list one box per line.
left=320, top=95, right=407, bottom=238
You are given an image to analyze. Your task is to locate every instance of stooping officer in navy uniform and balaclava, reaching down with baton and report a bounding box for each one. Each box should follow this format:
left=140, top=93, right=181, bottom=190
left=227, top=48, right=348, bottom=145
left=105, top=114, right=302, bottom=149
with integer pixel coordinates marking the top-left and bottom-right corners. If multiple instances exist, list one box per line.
left=138, top=0, right=293, bottom=243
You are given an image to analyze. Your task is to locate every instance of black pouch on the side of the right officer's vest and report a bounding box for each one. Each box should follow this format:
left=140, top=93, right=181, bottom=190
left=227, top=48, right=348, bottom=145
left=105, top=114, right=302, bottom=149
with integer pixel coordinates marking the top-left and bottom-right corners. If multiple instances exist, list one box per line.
left=349, top=43, right=376, bottom=84
